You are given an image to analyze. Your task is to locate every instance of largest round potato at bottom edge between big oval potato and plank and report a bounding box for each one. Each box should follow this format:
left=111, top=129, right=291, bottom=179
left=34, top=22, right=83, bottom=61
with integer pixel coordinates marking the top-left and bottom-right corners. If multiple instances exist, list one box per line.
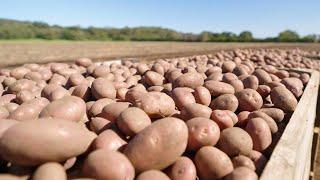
left=194, top=146, right=233, bottom=179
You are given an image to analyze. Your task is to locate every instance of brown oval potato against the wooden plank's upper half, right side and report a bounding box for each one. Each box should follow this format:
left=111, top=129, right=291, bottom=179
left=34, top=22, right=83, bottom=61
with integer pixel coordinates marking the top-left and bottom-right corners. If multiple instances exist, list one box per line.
left=270, top=86, right=298, bottom=112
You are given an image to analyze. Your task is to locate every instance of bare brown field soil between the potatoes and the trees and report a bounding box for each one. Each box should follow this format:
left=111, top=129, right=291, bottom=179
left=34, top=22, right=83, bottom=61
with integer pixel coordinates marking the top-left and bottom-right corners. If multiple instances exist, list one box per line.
left=0, top=40, right=320, bottom=179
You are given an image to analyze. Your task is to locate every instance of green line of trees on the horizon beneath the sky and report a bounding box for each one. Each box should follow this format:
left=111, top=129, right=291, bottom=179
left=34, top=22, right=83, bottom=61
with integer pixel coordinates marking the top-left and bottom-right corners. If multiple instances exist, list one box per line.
left=0, top=19, right=320, bottom=42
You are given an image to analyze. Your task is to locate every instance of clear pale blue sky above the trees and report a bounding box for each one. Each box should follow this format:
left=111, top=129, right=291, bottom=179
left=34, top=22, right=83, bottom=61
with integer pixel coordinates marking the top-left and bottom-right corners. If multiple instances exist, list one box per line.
left=0, top=0, right=320, bottom=37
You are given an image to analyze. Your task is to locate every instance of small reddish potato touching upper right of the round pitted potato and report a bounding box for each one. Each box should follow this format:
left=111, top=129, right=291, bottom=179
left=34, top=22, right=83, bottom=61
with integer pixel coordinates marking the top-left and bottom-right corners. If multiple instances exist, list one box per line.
left=210, top=110, right=234, bottom=130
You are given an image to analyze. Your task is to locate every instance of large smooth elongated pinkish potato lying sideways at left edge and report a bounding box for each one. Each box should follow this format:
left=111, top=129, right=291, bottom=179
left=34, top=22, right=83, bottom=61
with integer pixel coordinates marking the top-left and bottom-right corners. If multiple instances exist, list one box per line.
left=0, top=119, right=95, bottom=166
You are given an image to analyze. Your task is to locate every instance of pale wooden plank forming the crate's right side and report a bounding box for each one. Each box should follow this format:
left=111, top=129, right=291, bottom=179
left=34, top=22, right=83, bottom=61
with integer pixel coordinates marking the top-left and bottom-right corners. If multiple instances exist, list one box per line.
left=260, top=70, right=319, bottom=180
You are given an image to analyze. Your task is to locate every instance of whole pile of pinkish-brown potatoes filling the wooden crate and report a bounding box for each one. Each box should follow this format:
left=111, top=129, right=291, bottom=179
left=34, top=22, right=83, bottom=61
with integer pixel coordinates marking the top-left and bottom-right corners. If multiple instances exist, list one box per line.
left=0, top=51, right=310, bottom=180
